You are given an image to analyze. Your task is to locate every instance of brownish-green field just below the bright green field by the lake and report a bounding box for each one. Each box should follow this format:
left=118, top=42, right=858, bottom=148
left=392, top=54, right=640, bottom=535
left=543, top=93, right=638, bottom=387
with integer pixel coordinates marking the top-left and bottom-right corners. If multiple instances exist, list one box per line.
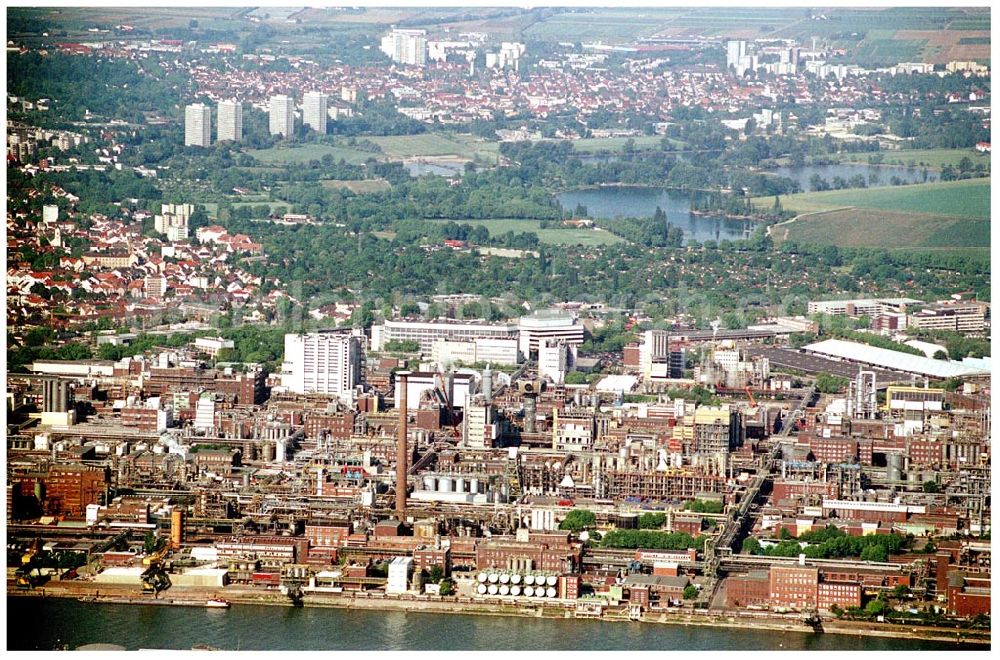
left=772, top=207, right=990, bottom=250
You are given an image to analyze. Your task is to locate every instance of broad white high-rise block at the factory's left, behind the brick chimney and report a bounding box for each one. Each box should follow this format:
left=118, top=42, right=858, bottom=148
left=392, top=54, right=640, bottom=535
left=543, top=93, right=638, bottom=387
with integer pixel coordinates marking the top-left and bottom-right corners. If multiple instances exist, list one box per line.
left=281, top=332, right=361, bottom=399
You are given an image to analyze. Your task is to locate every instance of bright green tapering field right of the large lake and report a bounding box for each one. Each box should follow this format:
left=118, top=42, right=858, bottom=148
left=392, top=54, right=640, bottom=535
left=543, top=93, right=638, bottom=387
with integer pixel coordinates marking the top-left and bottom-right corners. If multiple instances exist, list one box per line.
left=768, top=178, right=990, bottom=220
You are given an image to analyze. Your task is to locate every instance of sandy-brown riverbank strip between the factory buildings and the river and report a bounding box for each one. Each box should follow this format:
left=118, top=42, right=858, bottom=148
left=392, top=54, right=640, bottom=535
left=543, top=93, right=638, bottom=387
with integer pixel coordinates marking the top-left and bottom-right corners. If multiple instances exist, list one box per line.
left=7, top=582, right=990, bottom=648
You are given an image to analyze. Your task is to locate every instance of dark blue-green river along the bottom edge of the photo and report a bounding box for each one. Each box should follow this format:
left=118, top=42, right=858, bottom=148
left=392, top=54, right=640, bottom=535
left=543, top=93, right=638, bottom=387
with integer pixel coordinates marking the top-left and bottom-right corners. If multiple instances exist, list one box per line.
left=7, top=597, right=982, bottom=651
